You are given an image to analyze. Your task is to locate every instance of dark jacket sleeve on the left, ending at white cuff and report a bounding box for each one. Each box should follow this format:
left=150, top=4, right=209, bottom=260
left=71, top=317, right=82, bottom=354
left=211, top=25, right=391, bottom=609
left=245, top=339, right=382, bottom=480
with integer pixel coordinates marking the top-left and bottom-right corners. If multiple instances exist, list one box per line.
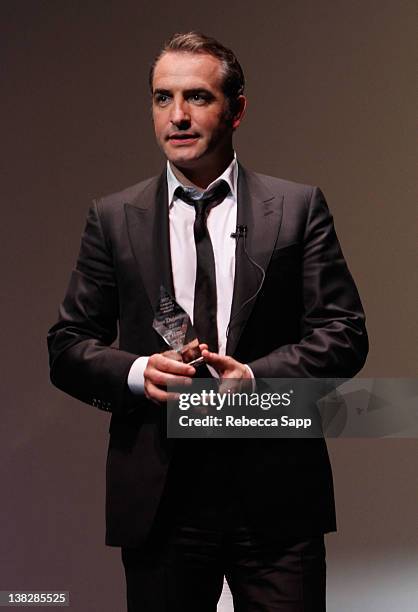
left=48, top=202, right=138, bottom=413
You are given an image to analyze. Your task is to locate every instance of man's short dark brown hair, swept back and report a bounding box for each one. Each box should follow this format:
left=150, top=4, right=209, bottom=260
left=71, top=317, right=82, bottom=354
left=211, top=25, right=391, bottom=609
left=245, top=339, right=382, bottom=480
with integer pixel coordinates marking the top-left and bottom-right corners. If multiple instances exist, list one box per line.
left=149, top=31, right=245, bottom=112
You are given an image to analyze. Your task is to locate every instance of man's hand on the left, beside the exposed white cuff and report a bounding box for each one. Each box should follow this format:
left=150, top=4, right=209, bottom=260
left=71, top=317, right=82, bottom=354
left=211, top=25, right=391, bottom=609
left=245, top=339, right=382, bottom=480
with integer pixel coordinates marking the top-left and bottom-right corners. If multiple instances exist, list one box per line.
left=144, top=351, right=196, bottom=404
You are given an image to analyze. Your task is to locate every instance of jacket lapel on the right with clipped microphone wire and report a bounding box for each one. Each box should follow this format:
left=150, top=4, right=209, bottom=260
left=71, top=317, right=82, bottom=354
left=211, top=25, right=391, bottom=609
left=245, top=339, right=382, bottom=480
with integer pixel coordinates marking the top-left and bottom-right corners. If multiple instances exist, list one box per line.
left=226, top=165, right=283, bottom=355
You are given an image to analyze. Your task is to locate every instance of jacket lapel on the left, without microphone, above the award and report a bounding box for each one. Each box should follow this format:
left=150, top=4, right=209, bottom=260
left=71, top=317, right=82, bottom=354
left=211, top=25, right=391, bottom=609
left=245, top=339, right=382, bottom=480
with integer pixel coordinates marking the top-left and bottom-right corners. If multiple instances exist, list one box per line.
left=125, top=171, right=174, bottom=311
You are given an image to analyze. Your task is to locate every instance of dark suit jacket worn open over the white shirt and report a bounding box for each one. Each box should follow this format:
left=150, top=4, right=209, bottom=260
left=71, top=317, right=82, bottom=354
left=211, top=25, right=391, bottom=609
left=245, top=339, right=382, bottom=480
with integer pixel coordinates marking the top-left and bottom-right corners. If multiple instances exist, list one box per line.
left=48, top=166, right=368, bottom=546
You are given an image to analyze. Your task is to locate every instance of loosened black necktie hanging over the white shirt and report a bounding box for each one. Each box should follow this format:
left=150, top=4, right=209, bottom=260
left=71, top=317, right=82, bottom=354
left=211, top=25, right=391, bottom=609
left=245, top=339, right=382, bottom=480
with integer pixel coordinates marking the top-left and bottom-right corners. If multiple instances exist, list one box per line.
left=174, top=181, right=230, bottom=353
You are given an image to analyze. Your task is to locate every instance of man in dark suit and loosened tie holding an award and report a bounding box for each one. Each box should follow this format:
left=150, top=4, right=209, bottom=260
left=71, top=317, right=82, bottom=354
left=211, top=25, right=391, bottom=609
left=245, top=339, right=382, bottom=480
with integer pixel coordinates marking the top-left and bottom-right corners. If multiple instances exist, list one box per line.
left=48, top=33, right=367, bottom=612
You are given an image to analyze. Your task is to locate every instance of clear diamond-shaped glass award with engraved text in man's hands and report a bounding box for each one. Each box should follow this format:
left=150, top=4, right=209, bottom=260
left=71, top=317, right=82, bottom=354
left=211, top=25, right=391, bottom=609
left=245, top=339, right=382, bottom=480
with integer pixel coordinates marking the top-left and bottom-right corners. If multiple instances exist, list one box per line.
left=152, top=285, right=204, bottom=367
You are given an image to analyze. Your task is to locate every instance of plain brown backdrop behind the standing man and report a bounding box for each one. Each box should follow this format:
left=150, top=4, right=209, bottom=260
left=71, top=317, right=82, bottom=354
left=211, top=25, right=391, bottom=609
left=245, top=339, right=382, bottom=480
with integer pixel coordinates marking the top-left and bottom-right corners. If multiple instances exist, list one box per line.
left=0, top=0, right=418, bottom=612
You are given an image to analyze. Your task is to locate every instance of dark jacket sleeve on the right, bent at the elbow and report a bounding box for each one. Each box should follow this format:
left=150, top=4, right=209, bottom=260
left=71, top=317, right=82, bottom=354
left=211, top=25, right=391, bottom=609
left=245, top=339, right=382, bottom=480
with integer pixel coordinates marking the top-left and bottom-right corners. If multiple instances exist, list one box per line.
left=248, top=188, right=368, bottom=378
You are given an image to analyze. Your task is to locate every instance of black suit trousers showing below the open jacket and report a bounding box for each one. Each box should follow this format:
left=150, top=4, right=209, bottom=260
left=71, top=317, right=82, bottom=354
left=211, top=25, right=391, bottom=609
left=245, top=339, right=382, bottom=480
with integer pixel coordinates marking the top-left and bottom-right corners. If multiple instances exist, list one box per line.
left=122, top=442, right=326, bottom=612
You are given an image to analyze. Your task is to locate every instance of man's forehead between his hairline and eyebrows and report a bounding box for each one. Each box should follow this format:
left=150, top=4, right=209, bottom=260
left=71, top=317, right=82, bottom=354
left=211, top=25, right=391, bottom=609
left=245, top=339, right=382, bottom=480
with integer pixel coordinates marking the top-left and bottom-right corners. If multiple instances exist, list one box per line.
left=153, top=51, right=222, bottom=89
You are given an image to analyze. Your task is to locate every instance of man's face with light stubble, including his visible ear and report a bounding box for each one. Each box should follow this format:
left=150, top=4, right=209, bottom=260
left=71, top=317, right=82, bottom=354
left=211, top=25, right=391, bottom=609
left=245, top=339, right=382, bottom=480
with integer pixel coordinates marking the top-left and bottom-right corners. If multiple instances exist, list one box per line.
left=152, top=52, right=242, bottom=170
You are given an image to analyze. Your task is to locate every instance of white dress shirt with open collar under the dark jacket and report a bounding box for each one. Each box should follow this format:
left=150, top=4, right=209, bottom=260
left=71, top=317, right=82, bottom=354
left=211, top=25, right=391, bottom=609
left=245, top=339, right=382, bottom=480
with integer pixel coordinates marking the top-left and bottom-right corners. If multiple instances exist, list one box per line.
left=128, top=155, right=243, bottom=393
